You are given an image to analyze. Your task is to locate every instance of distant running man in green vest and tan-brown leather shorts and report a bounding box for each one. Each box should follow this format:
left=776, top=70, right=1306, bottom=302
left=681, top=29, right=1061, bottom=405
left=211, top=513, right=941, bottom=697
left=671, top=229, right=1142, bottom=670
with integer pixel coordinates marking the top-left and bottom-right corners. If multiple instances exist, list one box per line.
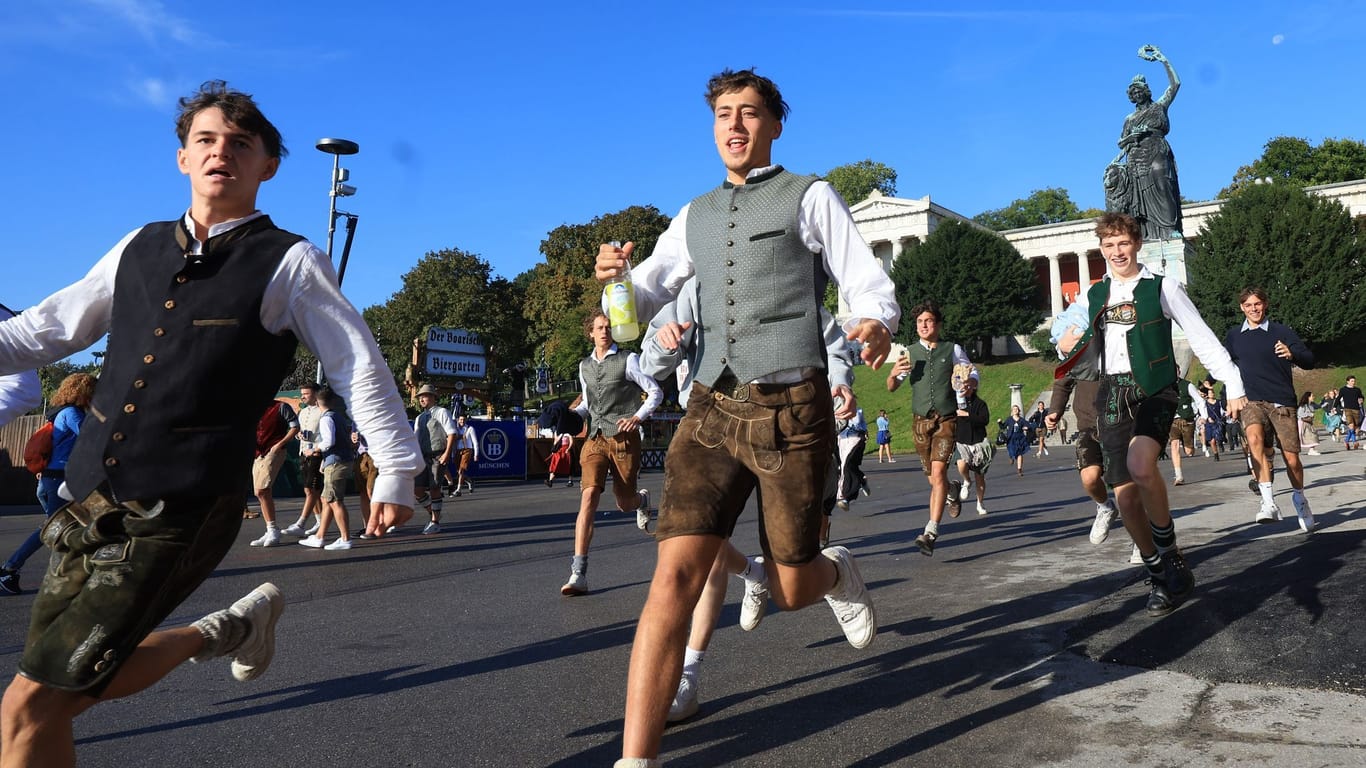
left=887, top=301, right=977, bottom=556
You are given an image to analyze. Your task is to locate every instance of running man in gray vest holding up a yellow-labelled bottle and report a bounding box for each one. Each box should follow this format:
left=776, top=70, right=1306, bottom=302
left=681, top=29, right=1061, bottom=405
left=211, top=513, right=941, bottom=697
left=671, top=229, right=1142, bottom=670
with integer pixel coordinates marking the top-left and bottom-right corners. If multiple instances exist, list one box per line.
left=596, top=70, right=900, bottom=768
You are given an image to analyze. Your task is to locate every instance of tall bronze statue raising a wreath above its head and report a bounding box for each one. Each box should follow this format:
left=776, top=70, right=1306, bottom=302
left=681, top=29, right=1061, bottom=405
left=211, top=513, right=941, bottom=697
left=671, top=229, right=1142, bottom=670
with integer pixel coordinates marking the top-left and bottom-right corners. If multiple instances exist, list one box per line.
left=1105, top=45, right=1182, bottom=241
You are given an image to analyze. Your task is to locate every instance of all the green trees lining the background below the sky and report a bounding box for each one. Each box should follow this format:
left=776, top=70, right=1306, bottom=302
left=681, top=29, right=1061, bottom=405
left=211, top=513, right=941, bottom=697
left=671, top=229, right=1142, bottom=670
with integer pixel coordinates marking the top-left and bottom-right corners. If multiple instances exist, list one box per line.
left=56, top=137, right=1366, bottom=404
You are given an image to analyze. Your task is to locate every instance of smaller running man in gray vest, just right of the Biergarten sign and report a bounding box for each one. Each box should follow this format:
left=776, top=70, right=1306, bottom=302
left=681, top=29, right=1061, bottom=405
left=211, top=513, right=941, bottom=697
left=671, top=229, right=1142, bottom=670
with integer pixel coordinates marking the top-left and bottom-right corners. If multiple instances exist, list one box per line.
left=560, top=310, right=664, bottom=596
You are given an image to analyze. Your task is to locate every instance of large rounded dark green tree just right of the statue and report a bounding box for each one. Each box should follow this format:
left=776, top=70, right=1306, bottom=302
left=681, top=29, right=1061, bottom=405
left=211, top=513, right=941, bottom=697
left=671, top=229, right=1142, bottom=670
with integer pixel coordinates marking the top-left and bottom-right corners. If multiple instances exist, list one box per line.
left=1186, top=183, right=1366, bottom=344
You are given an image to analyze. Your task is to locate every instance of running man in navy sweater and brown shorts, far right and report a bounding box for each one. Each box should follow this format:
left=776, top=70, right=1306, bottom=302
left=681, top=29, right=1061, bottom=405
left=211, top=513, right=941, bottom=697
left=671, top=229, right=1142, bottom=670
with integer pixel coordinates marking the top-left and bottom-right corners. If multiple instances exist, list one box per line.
left=1224, top=288, right=1318, bottom=533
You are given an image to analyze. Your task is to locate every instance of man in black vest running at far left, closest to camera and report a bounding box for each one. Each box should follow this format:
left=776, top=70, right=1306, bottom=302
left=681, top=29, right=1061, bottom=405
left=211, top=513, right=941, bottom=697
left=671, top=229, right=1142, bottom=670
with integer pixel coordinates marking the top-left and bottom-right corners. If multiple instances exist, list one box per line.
left=0, top=81, right=421, bottom=768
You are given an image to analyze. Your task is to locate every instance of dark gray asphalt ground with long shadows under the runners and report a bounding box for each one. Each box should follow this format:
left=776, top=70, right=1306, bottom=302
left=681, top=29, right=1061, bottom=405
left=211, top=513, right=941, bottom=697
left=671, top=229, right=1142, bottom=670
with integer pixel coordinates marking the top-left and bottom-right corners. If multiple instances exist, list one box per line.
left=0, top=434, right=1366, bottom=768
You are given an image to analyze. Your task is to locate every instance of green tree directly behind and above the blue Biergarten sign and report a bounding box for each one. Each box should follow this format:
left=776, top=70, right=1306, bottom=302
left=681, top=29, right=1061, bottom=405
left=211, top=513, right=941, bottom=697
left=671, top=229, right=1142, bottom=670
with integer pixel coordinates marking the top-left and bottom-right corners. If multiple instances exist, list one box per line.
left=363, top=249, right=529, bottom=381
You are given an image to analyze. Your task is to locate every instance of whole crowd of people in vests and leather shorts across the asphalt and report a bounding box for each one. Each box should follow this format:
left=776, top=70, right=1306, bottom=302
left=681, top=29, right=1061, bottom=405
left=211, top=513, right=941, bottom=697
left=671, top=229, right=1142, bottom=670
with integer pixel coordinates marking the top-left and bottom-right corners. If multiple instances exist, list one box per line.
left=0, top=70, right=1362, bottom=768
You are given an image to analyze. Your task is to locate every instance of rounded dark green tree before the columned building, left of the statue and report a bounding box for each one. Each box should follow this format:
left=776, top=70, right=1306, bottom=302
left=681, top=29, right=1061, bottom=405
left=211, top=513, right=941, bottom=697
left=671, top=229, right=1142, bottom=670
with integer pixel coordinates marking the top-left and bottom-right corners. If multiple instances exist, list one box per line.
left=891, top=220, right=1042, bottom=359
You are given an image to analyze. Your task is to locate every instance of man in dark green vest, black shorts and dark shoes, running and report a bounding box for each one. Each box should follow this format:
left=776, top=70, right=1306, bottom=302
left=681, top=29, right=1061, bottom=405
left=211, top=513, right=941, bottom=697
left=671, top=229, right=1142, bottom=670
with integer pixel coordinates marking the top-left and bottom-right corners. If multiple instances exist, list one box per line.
left=1059, top=213, right=1247, bottom=616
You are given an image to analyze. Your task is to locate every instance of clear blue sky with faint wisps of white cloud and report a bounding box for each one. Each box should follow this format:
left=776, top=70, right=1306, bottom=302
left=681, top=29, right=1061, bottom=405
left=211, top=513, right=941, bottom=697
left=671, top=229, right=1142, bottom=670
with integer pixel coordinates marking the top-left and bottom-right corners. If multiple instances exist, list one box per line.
left=0, top=0, right=1366, bottom=360
